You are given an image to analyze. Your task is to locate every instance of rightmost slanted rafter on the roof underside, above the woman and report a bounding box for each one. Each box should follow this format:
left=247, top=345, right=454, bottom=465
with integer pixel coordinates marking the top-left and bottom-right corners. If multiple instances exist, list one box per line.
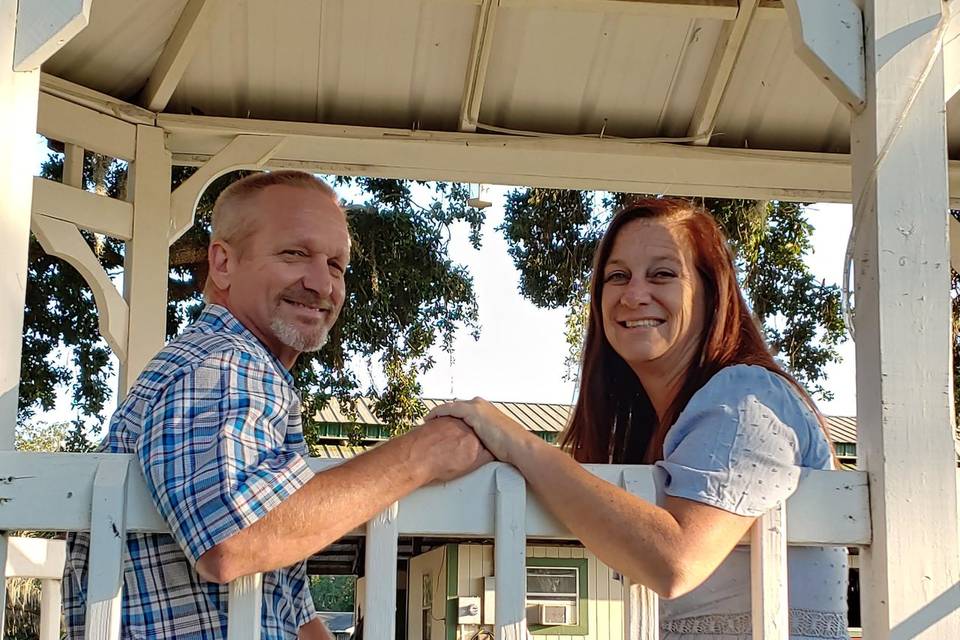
left=687, top=0, right=760, bottom=145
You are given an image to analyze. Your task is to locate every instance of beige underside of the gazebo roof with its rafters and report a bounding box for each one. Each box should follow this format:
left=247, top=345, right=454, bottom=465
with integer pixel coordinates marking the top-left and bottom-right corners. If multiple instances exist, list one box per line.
left=37, top=0, right=960, bottom=160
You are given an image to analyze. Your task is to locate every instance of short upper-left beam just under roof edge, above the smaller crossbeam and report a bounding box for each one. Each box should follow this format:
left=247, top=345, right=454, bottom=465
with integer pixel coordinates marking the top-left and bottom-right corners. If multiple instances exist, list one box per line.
left=35, top=93, right=137, bottom=160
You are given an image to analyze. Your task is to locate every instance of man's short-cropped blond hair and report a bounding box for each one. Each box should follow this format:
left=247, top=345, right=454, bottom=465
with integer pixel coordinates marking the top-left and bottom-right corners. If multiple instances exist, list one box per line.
left=210, top=169, right=337, bottom=249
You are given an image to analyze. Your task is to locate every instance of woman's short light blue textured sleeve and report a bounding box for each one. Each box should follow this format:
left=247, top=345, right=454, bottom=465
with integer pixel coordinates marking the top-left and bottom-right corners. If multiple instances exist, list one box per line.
left=657, top=366, right=806, bottom=516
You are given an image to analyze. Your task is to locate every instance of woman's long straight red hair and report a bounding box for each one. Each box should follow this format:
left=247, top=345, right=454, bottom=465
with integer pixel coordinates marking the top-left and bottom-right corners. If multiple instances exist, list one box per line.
left=560, top=198, right=829, bottom=464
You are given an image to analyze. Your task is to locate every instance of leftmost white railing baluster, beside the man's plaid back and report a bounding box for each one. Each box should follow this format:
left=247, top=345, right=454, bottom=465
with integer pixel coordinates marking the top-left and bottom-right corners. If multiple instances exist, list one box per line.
left=84, top=456, right=130, bottom=640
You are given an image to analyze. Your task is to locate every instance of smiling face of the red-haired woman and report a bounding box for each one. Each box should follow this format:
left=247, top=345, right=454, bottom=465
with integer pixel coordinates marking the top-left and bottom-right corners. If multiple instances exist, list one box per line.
left=600, top=219, right=704, bottom=380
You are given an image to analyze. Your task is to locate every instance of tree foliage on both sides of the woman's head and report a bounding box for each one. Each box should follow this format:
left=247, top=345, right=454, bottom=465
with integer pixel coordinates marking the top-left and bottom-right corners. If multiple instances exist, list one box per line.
left=500, top=189, right=844, bottom=399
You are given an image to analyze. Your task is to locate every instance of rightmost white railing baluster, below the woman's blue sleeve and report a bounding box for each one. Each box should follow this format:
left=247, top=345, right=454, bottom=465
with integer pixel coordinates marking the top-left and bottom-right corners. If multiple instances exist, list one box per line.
left=750, top=502, right=790, bottom=640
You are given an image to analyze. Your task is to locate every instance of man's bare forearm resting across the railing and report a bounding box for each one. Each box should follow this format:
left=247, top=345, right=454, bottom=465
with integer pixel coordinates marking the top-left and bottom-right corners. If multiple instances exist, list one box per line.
left=197, top=433, right=433, bottom=583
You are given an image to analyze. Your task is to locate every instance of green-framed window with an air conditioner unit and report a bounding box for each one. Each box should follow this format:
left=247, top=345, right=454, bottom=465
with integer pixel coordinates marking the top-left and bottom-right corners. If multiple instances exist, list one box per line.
left=526, top=558, right=588, bottom=635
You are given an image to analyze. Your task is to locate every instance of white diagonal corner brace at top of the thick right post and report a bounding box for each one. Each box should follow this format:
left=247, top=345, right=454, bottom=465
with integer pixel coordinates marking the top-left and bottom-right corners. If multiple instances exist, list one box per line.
left=783, top=0, right=866, bottom=113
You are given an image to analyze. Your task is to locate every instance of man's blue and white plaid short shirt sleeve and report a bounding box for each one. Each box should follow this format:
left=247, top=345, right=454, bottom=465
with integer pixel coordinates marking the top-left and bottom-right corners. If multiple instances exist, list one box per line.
left=137, top=351, right=313, bottom=564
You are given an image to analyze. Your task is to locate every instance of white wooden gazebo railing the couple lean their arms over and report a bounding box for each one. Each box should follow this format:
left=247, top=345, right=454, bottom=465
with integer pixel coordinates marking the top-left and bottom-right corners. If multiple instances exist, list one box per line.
left=0, top=452, right=870, bottom=640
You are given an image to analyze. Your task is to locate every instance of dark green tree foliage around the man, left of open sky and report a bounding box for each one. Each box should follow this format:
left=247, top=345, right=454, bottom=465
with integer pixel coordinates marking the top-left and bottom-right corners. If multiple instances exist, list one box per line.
left=20, top=150, right=484, bottom=440
